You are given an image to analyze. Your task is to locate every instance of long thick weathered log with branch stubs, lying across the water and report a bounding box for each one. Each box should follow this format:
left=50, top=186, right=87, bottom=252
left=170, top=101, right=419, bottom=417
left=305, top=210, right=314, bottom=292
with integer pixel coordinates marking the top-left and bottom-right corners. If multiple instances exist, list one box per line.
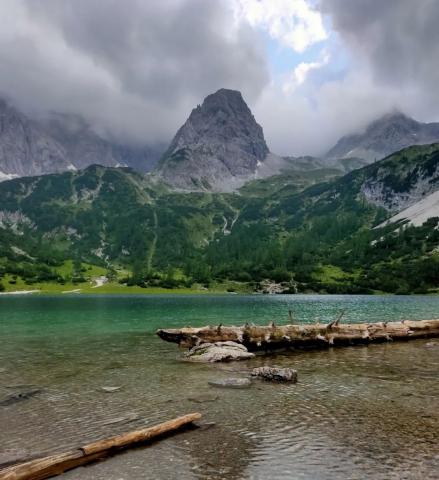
left=157, top=320, right=439, bottom=350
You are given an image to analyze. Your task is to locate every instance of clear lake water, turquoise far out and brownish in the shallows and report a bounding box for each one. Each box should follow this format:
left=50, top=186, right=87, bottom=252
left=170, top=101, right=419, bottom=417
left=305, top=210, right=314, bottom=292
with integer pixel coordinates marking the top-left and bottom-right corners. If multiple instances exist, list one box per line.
left=0, top=295, right=439, bottom=480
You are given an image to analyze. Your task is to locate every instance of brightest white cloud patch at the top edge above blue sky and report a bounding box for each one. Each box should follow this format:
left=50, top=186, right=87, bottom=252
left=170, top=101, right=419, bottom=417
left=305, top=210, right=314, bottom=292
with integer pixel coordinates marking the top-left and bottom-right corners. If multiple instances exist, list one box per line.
left=233, top=0, right=327, bottom=52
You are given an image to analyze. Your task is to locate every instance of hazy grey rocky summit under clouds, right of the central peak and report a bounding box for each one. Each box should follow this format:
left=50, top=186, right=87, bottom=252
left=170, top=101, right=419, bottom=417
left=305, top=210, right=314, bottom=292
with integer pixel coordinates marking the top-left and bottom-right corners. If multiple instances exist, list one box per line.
left=326, top=112, right=439, bottom=163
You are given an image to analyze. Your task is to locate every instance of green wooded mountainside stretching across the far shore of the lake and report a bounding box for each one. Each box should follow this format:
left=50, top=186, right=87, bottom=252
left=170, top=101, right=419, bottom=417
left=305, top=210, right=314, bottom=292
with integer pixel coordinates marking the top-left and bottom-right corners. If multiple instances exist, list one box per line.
left=0, top=145, right=439, bottom=293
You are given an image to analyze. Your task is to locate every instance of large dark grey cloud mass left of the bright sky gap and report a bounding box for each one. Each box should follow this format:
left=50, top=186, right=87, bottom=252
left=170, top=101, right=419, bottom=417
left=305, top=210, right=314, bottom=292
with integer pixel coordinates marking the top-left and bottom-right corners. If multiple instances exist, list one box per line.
left=0, top=0, right=269, bottom=141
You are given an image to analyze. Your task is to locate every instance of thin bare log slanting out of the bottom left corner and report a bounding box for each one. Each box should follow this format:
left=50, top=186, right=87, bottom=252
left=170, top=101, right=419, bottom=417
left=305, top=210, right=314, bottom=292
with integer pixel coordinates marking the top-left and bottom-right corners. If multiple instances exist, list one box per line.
left=0, top=413, right=201, bottom=480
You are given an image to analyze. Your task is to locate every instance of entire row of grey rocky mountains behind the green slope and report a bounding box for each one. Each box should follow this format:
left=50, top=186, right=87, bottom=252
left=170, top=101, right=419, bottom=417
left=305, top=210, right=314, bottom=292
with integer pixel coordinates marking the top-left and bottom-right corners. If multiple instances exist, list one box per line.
left=0, top=89, right=439, bottom=199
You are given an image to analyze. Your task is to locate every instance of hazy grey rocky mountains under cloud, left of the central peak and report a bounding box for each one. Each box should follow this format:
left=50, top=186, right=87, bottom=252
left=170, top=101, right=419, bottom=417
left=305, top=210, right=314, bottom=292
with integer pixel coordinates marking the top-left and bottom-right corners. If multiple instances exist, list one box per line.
left=0, top=100, right=165, bottom=181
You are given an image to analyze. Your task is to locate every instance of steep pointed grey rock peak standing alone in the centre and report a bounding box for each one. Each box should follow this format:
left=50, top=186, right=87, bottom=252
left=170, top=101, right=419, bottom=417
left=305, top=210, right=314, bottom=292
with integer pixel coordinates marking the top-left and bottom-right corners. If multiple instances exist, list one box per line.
left=156, top=89, right=269, bottom=191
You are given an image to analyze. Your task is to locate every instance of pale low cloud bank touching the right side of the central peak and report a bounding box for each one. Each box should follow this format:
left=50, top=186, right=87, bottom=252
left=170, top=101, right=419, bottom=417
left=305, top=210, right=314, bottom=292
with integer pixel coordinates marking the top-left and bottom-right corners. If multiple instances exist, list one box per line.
left=254, top=71, right=398, bottom=156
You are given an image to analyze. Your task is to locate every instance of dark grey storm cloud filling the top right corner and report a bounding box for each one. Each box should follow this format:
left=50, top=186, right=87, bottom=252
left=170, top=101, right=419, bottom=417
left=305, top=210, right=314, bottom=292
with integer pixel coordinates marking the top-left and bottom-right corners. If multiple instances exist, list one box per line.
left=320, top=0, right=439, bottom=95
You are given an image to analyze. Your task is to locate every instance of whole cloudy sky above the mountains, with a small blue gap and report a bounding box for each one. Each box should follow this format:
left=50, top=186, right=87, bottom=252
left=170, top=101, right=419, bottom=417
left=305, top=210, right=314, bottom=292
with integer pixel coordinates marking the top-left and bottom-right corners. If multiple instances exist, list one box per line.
left=0, top=0, right=439, bottom=155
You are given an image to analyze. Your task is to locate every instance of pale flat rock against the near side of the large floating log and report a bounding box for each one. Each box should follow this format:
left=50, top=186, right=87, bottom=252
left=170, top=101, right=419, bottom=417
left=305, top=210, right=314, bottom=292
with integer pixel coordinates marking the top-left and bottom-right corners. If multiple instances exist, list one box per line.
left=184, top=342, right=255, bottom=363
